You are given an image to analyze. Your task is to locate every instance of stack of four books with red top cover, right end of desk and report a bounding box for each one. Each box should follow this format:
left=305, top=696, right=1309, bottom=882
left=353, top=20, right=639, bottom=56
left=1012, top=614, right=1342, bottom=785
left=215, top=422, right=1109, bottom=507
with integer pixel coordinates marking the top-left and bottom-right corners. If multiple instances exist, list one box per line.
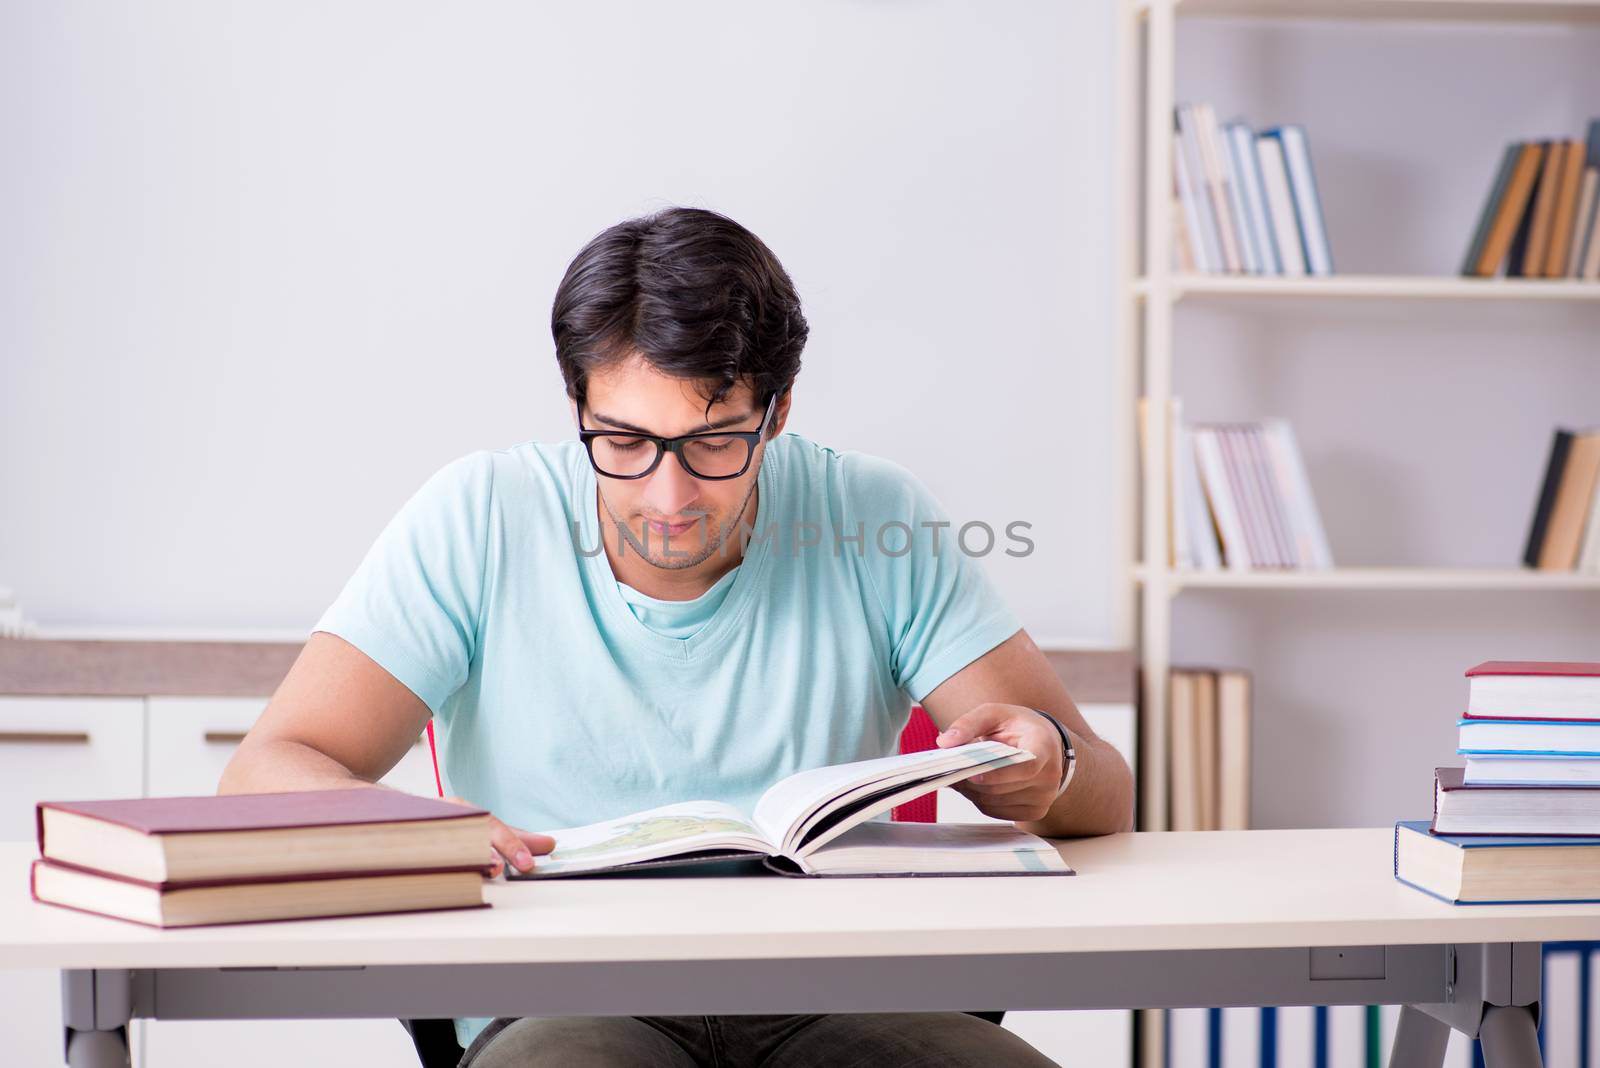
left=1394, top=660, right=1600, bottom=905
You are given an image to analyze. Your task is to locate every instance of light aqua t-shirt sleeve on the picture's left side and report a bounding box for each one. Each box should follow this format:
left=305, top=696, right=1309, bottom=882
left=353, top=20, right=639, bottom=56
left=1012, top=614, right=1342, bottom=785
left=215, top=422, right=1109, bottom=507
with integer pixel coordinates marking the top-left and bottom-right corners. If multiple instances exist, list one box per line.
left=312, top=452, right=494, bottom=715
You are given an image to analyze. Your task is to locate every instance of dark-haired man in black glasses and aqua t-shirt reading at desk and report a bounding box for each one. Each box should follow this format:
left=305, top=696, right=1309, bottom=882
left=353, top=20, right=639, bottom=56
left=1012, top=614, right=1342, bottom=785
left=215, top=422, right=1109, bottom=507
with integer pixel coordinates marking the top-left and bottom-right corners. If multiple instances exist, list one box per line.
left=221, top=209, right=1133, bottom=1068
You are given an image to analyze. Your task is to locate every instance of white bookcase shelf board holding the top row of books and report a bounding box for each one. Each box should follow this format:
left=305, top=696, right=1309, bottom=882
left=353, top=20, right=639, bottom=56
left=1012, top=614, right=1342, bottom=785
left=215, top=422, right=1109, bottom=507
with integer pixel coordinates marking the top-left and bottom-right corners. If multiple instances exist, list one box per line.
left=1133, top=275, right=1600, bottom=302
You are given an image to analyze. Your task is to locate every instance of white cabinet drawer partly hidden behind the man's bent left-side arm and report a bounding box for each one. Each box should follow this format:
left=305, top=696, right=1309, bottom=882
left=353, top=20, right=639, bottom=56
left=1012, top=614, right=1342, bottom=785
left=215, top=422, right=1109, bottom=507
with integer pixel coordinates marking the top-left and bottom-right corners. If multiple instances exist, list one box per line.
left=147, top=697, right=438, bottom=796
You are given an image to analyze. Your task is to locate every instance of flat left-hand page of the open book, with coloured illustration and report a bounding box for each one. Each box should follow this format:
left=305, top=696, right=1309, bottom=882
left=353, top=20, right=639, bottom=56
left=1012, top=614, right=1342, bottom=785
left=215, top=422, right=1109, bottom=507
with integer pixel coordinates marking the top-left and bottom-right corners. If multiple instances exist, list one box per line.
left=534, top=801, right=774, bottom=875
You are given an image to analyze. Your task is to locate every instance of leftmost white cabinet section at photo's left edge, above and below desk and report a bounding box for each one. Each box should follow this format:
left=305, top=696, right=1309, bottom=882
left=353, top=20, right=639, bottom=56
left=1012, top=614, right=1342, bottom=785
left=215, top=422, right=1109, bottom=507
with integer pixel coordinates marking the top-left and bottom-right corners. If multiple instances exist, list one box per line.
left=0, top=697, right=144, bottom=1065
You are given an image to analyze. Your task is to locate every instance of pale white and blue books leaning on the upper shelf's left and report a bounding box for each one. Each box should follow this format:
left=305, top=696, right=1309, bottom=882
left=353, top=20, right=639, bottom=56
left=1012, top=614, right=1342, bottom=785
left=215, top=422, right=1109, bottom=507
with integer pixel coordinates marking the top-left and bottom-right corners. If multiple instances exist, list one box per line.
left=1173, top=104, right=1333, bottom=275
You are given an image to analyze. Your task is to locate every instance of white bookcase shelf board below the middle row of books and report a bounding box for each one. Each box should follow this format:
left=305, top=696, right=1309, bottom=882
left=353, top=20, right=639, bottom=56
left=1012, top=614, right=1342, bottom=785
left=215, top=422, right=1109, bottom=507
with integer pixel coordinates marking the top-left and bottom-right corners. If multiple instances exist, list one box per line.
left=1133, top=566, right=1600, bottom=595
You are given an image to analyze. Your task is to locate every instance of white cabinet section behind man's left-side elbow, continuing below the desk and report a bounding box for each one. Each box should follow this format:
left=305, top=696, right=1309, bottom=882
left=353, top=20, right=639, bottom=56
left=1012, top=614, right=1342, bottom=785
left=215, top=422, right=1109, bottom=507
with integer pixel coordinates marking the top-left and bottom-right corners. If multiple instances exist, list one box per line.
left=134, top=697, right=438, bottom=1068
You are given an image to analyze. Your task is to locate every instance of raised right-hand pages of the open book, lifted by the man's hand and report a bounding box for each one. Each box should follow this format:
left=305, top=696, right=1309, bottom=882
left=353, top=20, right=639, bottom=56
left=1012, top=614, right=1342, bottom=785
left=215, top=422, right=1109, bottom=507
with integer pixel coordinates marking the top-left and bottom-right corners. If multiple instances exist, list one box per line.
left=755, top=742, right=1034, bottom=852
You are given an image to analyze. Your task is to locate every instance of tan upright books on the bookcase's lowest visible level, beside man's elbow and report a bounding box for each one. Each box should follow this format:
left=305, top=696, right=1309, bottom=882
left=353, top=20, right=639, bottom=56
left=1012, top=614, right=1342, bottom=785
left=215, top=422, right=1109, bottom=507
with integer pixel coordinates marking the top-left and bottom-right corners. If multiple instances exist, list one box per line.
left=1166, top=668, right=1251, bottom=831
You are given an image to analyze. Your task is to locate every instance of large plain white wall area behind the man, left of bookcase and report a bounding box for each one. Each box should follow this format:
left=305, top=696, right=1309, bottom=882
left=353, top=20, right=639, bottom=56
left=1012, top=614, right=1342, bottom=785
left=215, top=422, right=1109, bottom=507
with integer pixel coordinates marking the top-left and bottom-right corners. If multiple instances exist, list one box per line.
left=0, top=0, right=1120, bottom=641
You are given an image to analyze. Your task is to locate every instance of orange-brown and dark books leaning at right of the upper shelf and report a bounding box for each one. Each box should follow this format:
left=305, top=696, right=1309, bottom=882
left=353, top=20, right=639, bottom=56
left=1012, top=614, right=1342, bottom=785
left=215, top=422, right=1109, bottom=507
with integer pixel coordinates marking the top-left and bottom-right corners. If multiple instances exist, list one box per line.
left=1461, top=118, right=1600, bottom=281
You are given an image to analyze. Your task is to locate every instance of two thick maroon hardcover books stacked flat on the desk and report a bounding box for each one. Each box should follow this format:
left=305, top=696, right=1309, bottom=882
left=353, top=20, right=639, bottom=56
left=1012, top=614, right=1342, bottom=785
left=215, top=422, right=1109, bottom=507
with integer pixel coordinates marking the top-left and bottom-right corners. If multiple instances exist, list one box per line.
left=29, top=787, right=490, bottom=927
